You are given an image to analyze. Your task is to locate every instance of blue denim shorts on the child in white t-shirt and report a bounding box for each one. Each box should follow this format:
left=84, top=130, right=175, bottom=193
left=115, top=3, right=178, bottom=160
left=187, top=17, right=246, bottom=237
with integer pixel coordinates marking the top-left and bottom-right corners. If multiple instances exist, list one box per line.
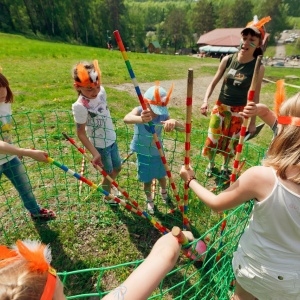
left=96, top=142, right=122, bottom=174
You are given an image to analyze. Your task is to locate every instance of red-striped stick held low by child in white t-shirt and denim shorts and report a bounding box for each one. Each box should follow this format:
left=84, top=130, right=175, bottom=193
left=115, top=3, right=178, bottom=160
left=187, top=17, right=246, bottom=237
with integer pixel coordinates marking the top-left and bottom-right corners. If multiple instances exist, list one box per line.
left=62, top=132, right=168, bottom=233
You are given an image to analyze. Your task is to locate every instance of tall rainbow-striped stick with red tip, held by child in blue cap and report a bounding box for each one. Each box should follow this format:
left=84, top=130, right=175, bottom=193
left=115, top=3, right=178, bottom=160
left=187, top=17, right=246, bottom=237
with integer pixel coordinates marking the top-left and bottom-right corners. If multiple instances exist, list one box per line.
left=114, top=30, right=183, bottom=212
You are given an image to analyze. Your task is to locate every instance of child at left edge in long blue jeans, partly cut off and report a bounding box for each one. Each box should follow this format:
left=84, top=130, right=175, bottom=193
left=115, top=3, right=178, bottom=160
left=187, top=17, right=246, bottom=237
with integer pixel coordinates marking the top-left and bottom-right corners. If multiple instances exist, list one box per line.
left=0, top=73, right=56, bottom=221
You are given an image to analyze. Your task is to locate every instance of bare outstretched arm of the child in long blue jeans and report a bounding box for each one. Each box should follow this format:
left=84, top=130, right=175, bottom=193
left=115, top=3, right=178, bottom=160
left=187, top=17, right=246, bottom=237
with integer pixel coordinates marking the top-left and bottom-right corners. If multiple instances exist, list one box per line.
left=0, top=141, right=48, bottom=162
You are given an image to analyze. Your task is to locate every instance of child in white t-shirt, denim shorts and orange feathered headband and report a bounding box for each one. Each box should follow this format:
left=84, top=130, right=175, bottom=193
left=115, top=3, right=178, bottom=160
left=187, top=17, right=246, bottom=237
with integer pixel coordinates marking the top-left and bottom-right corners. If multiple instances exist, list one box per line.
left=72, top=60, right=121, bottom=204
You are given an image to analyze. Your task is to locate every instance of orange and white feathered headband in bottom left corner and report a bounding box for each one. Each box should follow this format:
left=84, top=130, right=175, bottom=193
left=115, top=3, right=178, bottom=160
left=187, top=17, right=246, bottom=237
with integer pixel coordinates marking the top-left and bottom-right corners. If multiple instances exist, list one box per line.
left=0, top=240, right=57, bottom=300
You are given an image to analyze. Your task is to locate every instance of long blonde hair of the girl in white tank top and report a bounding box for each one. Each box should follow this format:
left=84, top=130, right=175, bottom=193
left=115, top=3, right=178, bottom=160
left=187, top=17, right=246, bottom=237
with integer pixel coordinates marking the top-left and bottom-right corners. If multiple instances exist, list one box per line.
left=264, top=93, right=300, bottom=184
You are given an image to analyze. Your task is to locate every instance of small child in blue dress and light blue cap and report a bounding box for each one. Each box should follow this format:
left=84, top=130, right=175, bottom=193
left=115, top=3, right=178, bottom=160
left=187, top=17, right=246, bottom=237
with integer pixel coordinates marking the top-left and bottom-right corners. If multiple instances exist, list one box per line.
left=124, top=83, right=184, bottom=214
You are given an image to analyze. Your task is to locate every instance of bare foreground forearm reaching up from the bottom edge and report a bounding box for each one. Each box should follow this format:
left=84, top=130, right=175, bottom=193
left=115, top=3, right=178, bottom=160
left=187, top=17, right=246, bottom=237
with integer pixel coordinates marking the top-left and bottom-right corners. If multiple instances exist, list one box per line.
left=103, top=233, right=190, bottom=300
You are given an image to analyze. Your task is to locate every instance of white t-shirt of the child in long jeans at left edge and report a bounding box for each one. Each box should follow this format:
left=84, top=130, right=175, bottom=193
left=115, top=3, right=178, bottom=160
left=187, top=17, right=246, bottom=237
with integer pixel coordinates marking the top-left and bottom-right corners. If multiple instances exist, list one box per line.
left=0, top=102, right=16, bottom=165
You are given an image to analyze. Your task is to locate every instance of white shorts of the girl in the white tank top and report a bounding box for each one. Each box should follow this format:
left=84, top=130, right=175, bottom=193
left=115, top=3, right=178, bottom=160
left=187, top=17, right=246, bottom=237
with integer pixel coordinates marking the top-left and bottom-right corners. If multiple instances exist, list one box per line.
left=232, top=248, right=300, bottom=300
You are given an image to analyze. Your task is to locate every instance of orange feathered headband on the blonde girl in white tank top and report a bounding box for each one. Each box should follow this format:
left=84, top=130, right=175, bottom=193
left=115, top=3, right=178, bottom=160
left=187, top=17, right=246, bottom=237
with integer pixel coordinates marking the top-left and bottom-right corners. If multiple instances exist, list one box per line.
left=274, top=79, right=300, bottom=126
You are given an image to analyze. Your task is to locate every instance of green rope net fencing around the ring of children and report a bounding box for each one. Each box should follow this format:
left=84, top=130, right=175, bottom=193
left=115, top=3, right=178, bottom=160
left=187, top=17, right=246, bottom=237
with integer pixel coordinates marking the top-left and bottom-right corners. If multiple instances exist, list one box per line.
left=0, top=111, right=265, bottom=299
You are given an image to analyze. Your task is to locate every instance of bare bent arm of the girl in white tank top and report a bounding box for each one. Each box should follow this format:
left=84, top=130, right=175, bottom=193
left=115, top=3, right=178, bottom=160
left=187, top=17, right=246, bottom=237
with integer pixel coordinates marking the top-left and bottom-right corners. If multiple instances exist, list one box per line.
left=180, top=166, right=275, bottom=212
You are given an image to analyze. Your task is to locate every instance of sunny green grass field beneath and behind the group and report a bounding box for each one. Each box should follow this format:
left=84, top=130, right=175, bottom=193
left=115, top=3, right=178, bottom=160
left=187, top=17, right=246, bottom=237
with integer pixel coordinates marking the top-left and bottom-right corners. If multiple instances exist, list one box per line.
left=0, top=33, right=300, bottom=299
